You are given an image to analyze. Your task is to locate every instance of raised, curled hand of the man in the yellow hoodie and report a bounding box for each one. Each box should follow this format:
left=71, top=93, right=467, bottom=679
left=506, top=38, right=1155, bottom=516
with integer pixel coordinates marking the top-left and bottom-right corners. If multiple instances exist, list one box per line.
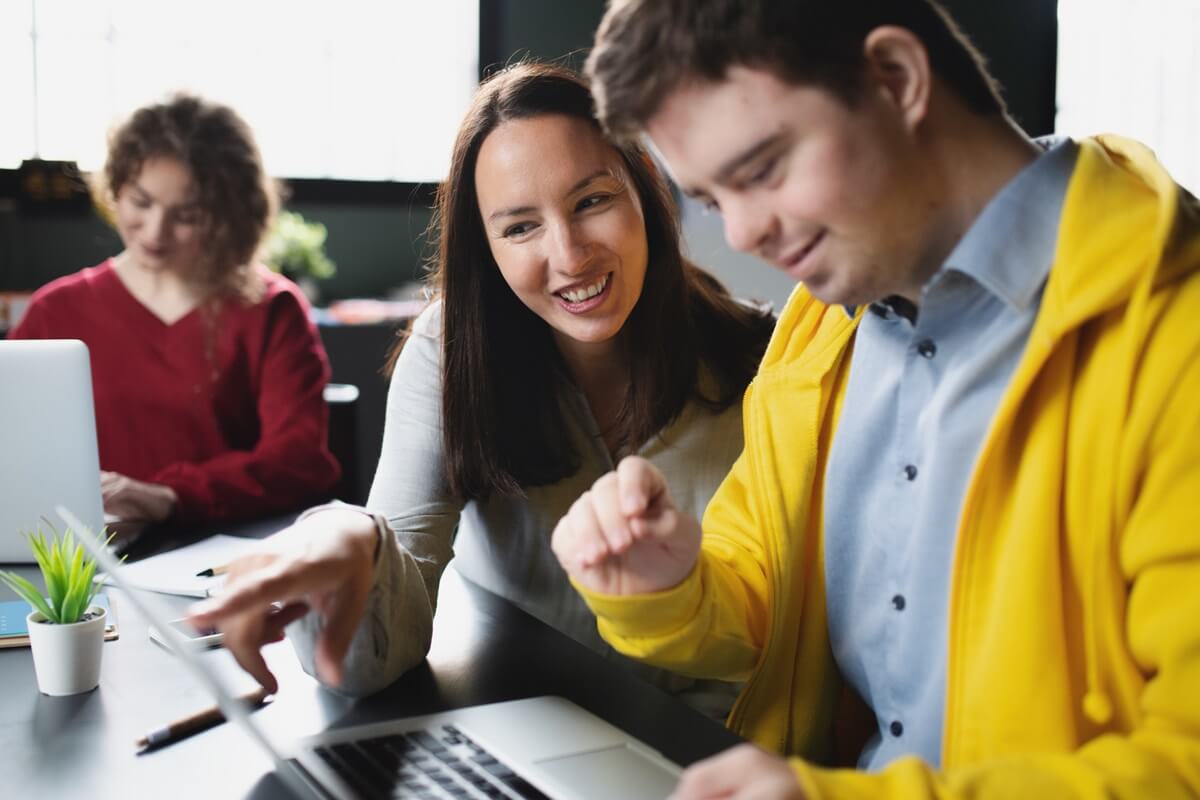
left=551, top=456, right=700, bottom=595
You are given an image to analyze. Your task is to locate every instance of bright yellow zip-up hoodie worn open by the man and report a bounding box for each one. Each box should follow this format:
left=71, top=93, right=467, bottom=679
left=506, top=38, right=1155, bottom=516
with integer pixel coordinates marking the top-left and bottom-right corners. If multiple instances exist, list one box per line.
left=583, top=137, right=1200, bottom=799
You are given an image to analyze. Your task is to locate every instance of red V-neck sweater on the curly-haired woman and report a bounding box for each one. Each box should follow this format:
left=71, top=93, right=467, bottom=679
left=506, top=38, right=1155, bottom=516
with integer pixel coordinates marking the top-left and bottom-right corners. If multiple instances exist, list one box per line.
left=8, top=260, right=338, bottom=523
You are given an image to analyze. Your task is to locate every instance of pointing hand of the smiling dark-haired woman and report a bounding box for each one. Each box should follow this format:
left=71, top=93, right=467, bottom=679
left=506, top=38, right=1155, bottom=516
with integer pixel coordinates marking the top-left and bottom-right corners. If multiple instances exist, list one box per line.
left=188, top=509, right=379, bottom=692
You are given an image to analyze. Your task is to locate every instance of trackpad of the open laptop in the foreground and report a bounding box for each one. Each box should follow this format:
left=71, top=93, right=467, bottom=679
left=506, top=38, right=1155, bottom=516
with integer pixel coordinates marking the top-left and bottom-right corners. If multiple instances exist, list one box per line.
left=538, top=745, right=679, bottom=800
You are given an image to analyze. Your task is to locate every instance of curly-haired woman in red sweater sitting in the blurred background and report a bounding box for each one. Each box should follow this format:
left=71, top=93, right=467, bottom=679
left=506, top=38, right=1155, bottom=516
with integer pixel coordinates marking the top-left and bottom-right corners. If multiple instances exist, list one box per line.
left=10, top=95, right=338, bottom=530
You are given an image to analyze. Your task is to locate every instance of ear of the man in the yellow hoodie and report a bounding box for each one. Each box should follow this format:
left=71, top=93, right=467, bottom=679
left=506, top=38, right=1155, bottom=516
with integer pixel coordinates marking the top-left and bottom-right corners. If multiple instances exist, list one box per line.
left=863, top=25, right=934, bottom=130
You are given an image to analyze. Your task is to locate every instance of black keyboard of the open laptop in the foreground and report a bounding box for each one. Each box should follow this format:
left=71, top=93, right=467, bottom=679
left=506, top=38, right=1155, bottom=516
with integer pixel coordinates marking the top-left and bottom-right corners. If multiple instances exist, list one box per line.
left=313, top=726, right=548, bottom=800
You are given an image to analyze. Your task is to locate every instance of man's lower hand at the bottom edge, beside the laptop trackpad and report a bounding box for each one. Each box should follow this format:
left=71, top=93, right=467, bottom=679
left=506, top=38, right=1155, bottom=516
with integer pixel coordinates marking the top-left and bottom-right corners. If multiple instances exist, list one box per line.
left=671, top=745, right=805, bottom=800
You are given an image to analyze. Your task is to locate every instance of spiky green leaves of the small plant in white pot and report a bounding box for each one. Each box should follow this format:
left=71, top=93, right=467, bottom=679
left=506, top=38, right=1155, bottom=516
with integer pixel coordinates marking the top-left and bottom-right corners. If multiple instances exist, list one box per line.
left=0, top=523, right=115, bottom=625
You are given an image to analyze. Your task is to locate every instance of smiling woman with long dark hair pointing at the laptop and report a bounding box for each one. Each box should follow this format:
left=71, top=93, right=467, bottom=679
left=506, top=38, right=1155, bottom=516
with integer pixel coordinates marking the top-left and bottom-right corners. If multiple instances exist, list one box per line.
left=187, top=64, right=774, bottom=717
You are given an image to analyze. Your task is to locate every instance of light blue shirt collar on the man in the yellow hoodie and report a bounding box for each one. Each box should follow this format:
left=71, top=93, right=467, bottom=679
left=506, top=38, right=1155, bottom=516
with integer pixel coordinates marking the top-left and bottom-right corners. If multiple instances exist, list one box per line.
left=930, top=137, right=1079, bottom=311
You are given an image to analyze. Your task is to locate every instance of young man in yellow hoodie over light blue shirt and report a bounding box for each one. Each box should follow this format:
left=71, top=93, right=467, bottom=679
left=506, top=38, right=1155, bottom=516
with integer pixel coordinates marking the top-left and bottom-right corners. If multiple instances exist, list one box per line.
left=553, top=0, right=1200, bottom=798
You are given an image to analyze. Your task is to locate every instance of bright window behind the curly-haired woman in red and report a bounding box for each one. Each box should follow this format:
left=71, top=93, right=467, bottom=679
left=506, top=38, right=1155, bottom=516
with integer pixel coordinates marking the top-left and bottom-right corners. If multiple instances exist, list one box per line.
left=0, top=0, right=479, bottom=181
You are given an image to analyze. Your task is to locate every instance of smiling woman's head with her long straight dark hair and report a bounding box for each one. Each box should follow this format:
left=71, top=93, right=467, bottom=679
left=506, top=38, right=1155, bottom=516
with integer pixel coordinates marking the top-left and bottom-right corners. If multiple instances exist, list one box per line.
left=432, top=65, right=772, bottom=499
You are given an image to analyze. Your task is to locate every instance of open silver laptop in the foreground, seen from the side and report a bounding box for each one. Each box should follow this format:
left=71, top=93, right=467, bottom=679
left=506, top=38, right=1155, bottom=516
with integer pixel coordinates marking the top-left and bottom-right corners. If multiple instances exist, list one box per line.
left=58, top=506, right=679, bottom=800
